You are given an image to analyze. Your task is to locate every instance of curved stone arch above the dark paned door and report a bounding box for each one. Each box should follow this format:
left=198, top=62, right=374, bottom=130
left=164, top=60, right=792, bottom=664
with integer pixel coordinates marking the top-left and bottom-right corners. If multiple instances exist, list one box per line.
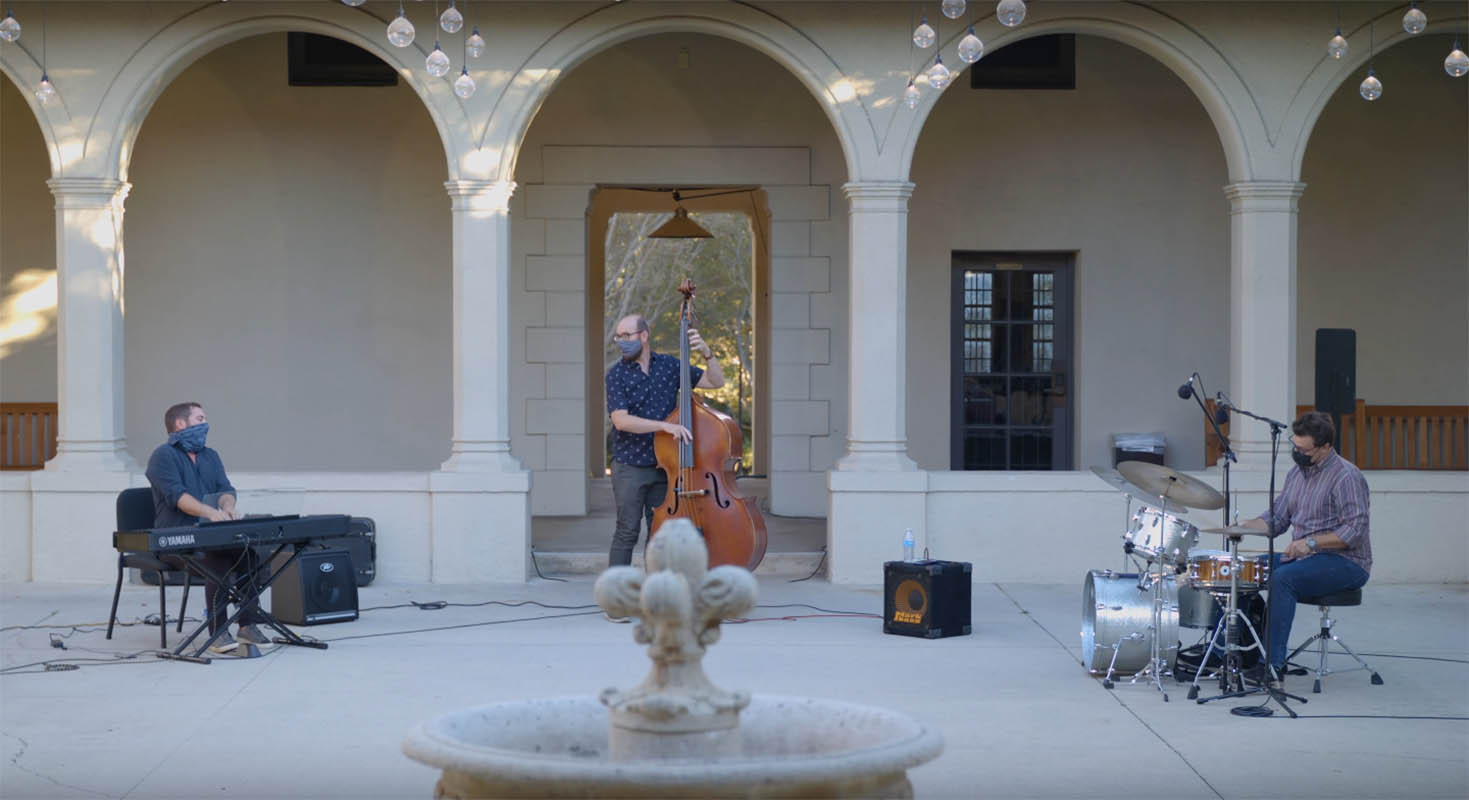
left=899, top=4, right=1268, bottom=182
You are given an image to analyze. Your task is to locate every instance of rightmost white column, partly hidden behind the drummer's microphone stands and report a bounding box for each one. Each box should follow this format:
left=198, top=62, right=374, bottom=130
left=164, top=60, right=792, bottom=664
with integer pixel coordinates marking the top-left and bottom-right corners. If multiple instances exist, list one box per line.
left=1224, top=181, right=1306, bottom=470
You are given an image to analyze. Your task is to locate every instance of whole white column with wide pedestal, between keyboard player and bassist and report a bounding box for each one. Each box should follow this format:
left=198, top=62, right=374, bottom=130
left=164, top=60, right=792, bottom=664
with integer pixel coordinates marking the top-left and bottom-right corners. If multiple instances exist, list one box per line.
left=429, top=181, right=530, bottom=583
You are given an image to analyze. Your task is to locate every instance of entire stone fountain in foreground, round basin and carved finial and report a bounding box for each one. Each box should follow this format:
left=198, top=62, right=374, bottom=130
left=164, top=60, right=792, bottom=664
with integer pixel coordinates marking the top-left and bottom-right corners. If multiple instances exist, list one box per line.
left=403, top=520, right=943, bottom=800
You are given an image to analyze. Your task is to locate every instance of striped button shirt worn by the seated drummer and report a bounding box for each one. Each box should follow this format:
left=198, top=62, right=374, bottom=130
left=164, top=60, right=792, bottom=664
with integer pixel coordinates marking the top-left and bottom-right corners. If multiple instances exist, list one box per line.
left=1260, top=449, right=1372, bottom=572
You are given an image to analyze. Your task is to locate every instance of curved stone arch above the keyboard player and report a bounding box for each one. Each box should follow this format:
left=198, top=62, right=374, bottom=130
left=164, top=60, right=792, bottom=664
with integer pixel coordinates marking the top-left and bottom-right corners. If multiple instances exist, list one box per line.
left=82, top=3, right=469, bottom=181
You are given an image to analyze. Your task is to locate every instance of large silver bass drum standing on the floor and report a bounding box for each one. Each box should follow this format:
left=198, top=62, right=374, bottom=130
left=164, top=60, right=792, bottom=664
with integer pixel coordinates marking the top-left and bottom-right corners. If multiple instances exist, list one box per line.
left=1081, top=570, right=1178, bottom=675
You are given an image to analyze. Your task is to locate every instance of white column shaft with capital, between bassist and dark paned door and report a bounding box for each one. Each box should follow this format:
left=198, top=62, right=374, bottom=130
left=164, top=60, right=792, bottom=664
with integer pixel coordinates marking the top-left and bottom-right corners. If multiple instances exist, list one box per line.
left=836, top=181, right=917, bottom=471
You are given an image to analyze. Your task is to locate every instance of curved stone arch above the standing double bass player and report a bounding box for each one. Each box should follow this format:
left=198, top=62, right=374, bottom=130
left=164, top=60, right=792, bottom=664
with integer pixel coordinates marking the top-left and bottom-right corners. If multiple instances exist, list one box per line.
left=476, top=3, right=877, bottom=181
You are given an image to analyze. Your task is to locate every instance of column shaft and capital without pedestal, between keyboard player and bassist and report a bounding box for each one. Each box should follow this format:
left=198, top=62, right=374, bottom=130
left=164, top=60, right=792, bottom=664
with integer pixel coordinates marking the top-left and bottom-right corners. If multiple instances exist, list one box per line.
left=442, top=181, right=521, bottom=473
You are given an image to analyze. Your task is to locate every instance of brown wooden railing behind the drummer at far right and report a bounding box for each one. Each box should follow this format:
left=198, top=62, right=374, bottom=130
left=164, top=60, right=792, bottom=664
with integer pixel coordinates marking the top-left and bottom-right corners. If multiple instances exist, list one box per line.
left=1205, top=399, right=1469, bottom=470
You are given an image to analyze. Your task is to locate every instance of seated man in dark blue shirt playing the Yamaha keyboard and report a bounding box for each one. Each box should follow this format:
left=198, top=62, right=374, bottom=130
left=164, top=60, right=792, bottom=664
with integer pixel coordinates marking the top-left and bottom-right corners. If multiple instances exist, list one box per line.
left=148, top=402, right=270, bottom=655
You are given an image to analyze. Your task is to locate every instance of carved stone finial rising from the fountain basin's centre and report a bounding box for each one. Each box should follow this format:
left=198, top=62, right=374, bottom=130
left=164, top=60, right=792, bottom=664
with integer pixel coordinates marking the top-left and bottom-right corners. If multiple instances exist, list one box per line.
left=595, top=518, right=755, bottom=753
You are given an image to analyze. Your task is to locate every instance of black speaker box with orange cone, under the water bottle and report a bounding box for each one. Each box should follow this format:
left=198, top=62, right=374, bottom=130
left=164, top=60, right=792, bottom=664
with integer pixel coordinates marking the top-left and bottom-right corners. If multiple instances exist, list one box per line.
left=883, top=561, right=974, bottom=639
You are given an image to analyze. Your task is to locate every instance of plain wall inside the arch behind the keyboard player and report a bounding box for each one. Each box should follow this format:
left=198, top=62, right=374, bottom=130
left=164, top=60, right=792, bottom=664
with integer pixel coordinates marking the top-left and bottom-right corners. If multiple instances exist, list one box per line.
left=125, top=34, right=452, bottom=470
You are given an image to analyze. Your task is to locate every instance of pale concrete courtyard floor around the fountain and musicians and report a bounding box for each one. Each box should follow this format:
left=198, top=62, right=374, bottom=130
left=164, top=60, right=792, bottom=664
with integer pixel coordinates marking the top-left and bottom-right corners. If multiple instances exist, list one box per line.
left=0, top=577, right=1469, bottom=799
